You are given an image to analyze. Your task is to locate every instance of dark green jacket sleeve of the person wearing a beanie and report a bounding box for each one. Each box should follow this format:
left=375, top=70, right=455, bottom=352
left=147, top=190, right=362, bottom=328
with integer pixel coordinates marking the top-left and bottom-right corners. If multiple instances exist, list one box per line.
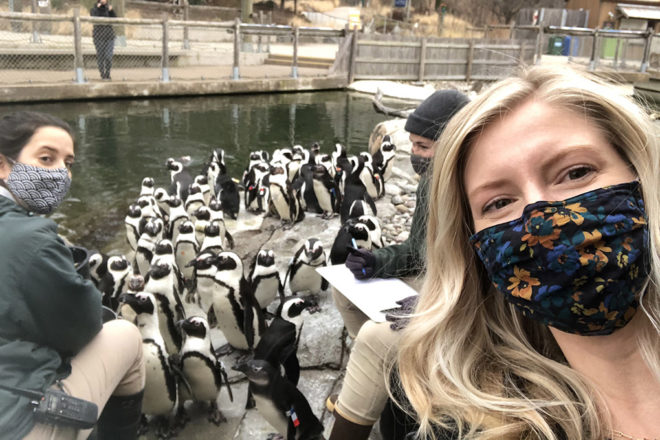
left=374, top=176, right=429, bottom=278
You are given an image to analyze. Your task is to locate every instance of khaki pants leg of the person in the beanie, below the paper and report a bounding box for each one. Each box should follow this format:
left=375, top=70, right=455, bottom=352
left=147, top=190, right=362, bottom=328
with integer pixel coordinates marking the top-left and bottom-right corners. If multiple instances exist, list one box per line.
left=332, top=288, right=401, bottom=425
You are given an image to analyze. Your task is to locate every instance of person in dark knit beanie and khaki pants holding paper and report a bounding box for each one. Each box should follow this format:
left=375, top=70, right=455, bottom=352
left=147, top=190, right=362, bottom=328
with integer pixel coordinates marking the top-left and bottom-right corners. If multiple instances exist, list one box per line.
left=326, top=90, right=468, bottom=440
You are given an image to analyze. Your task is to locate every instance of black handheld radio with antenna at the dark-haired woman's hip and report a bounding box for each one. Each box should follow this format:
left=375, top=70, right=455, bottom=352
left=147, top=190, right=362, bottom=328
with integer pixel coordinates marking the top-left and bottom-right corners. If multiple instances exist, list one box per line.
left=0, top=384, right=99, bottom=429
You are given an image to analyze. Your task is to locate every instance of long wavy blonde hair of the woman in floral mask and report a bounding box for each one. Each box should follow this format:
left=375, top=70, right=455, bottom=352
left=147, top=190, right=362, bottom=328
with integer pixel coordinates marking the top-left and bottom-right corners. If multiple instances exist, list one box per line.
left=398, top=67, right=660, bottom=439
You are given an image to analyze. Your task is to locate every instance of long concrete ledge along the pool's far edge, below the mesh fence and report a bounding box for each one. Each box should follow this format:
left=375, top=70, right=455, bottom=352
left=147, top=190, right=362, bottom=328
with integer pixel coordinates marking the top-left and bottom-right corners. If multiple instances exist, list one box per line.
left=0, top=76, right=348, bottom=103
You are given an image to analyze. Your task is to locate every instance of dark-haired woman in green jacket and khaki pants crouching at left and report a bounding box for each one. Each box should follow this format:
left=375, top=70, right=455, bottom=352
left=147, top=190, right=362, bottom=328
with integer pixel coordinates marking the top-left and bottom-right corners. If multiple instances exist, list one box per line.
left=0, top=112, right=144, bottom=439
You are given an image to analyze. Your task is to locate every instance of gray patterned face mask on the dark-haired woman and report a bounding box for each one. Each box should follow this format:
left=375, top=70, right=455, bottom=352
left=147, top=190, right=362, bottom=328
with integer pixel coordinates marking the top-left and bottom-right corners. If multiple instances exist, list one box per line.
left=5, top=159, right=71, bottom=214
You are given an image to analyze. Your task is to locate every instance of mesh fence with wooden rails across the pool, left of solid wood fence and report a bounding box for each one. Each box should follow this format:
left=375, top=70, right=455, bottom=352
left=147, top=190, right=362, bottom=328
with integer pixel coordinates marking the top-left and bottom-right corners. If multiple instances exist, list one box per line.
left=0, top=10, right=345, bottom=84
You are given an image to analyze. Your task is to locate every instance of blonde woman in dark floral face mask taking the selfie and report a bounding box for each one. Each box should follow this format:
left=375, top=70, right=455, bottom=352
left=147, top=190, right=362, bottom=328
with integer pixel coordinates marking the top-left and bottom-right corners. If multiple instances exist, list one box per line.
left=398, top=67, right=660, bottom=439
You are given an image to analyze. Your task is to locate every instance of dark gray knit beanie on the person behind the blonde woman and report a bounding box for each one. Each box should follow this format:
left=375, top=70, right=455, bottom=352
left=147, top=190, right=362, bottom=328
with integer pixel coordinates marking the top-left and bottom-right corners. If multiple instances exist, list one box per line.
left=405, top=90, right=469, bottom=140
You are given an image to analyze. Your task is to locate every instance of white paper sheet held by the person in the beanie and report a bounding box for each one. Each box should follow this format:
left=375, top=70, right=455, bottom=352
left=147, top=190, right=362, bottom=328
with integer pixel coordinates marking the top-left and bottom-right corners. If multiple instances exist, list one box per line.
left=316, top=264, right=417, bottom=322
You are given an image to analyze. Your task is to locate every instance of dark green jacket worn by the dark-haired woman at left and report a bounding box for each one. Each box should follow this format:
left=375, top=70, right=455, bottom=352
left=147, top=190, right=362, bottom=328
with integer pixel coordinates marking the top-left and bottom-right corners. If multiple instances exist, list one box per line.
left=0, top=196, right=102, bottom=439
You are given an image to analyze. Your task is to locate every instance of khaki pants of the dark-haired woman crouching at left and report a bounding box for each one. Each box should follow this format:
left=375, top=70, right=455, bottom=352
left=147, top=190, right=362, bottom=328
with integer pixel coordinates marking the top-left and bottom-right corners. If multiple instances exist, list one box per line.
left=25, top=319, right=145, bottom=440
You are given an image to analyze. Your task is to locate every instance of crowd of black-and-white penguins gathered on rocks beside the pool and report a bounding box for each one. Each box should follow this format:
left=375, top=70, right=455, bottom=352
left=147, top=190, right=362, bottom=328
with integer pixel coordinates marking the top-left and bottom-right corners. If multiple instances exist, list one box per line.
left=89, top=137, right=395, bottom=439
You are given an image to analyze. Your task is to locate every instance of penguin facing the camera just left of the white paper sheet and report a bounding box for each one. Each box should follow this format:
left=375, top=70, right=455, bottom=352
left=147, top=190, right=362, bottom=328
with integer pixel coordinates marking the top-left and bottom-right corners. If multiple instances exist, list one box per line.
left=284, top=238, right=328, bottom=295
